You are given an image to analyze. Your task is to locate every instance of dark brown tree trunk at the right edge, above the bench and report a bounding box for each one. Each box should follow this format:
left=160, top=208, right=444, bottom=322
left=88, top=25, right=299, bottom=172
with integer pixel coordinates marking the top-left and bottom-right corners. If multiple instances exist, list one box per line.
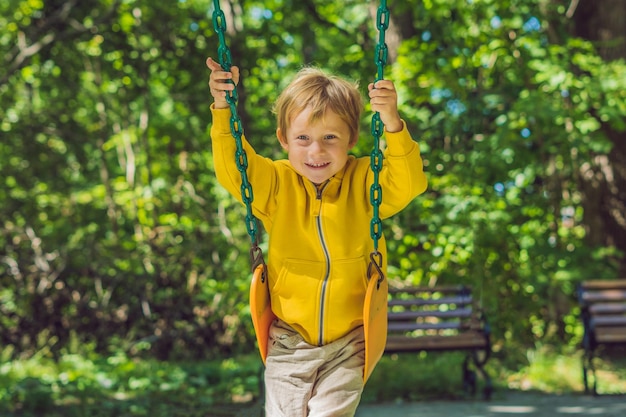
left=567, top=0, right=626, bottom=276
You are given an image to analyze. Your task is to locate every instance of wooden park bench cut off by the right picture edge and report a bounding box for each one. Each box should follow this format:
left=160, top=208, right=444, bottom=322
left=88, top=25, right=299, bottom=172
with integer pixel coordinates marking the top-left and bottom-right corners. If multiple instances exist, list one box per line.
left=578, top=279, right=626, bottom=395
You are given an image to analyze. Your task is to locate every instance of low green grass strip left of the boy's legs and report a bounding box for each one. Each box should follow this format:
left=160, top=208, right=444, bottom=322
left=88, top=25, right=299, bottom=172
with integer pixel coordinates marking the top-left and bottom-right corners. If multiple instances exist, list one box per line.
left=0, top=353, right=260, bottom=416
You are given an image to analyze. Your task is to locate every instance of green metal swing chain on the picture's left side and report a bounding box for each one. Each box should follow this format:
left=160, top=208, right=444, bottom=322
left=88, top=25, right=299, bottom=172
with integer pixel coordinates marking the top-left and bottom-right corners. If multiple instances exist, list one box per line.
left=213, top=0, right=262, bottom=268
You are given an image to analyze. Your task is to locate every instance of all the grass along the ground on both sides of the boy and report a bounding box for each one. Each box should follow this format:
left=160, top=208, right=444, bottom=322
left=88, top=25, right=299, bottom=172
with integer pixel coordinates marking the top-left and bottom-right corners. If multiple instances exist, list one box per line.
left=0, top=342, right=626, bottom=417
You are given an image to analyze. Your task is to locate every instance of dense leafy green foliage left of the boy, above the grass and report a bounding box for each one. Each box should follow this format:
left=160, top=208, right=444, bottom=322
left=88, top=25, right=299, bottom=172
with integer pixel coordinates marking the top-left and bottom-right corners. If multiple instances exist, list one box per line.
left=0, top=1, right=251, bottom=358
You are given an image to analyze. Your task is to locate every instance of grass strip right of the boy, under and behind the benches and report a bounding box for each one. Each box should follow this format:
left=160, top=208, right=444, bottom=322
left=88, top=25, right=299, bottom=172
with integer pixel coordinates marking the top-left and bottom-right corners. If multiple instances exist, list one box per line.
left=363, top=346, right=626, bottom=403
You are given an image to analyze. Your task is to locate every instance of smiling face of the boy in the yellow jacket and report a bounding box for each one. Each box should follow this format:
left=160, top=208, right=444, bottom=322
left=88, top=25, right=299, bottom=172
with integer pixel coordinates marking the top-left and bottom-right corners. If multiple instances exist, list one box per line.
left=276, top=107, right=356, bottom=184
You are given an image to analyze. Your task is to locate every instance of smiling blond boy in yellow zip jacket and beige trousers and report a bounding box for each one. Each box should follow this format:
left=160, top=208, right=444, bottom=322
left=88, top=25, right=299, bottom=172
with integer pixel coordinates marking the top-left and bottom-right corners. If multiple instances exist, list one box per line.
left=206, top=58, right=427, bottom=417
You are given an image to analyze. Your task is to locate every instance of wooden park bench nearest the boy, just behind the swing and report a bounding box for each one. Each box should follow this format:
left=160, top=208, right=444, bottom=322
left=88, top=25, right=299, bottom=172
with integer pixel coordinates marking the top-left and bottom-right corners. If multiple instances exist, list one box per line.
left=385, top=285, right=493, bottom=399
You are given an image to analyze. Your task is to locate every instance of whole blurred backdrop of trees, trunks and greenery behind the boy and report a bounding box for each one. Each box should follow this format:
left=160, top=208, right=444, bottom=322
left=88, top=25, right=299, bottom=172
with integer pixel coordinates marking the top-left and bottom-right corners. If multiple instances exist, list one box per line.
left=0, top=0, right=626, bottom=415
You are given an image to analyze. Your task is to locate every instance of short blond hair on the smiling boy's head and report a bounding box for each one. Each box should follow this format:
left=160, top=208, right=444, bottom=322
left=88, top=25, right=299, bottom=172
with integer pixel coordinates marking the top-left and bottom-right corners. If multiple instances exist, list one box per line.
left=274, top=68, right=363, bottom=143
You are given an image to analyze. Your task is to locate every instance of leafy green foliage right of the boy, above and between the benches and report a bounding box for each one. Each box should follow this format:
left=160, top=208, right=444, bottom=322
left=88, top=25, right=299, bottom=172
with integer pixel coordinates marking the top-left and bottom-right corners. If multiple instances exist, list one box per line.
left=380, top=1, right=624, bottom=357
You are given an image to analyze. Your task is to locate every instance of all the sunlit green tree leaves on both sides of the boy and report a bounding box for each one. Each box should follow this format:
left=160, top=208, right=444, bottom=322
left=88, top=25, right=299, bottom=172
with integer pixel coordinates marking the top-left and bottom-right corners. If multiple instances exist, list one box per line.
left=0, top=0, right=626, bottom=362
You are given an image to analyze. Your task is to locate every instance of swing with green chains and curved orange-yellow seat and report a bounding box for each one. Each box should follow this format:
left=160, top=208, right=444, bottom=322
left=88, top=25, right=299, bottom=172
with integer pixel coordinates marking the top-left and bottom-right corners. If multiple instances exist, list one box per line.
left=213, top=0, right=389, bottom=381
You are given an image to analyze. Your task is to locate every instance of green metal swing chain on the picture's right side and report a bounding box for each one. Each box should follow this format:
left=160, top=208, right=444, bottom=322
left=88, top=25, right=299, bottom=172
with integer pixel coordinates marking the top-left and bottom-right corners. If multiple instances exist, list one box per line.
left=368, top=0, right=389, bottom=279
